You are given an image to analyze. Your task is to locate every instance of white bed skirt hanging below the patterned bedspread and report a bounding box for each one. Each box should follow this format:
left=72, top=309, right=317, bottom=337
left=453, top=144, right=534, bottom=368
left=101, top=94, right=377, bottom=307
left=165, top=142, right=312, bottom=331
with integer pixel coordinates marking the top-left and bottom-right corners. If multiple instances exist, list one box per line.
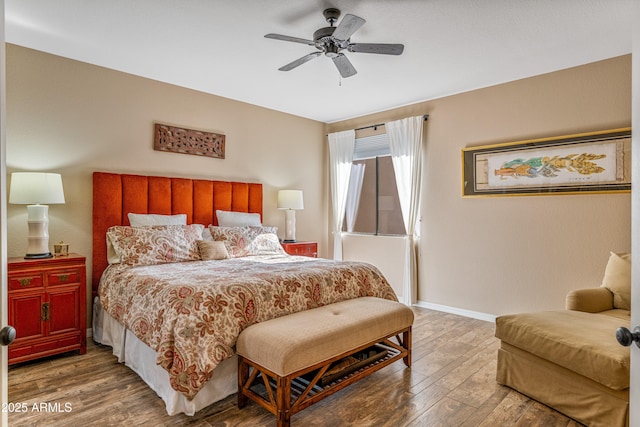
left=93, top=298, right=238, bottom=415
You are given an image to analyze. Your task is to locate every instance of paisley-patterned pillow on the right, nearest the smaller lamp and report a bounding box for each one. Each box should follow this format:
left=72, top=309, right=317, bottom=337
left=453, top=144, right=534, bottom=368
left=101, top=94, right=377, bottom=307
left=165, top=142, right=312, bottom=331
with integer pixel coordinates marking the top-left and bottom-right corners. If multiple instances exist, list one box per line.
left=209, top=225, right=285, bottom=258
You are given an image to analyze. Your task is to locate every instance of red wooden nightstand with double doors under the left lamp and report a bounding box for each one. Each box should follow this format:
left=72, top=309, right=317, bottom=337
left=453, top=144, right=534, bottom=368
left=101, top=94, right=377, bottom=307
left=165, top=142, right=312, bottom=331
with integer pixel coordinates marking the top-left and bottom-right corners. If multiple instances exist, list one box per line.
left=7, top=254, right=87, bottom=364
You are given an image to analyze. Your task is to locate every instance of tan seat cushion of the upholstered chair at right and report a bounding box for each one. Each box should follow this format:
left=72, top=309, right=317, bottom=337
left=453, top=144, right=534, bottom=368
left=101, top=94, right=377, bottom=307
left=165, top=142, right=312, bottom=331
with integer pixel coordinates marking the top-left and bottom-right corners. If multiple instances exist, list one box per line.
left=496, top=310, right=629, bottom=390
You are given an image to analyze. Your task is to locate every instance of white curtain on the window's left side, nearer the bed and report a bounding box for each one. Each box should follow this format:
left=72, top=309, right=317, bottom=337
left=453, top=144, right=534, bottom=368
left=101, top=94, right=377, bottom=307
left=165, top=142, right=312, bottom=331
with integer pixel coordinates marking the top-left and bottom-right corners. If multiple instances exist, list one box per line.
left=329, top=130, right=356, bottom=260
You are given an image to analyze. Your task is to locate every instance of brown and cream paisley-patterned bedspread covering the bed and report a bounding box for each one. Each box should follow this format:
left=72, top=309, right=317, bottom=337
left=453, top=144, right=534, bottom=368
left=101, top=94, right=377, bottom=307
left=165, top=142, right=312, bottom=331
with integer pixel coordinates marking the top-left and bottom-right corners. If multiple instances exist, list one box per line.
left=99, top=255, right=397, bottom=399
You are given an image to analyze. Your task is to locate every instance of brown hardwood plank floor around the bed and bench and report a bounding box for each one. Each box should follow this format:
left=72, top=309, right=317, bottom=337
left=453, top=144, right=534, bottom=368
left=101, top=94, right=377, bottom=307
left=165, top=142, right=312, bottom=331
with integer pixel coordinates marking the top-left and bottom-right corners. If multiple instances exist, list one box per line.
left=9, top=308, right=580, bottom=427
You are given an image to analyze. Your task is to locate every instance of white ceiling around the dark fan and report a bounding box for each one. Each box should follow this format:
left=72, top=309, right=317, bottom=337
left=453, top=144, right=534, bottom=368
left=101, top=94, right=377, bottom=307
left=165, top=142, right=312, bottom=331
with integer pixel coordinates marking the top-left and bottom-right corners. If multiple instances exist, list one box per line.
left=5, top=0, right=634, bottom=122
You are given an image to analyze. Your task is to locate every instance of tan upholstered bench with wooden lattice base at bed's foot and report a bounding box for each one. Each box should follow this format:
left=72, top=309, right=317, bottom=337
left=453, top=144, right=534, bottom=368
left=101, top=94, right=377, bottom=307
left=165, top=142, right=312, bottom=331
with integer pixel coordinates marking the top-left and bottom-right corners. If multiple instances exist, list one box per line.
left=236, top=297, right=413, bottom=427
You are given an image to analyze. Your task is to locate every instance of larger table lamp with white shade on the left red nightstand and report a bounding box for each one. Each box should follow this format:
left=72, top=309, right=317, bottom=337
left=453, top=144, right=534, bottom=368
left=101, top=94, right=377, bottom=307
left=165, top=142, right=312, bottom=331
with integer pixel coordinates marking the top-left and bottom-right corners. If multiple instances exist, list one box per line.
left=9, top=172, right=64, bottom=259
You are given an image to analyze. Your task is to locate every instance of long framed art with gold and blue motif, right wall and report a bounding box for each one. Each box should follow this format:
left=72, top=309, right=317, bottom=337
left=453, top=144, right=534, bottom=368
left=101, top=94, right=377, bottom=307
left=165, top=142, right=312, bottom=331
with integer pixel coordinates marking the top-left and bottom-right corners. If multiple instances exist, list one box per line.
left=462, top=128, right=631, bottom=197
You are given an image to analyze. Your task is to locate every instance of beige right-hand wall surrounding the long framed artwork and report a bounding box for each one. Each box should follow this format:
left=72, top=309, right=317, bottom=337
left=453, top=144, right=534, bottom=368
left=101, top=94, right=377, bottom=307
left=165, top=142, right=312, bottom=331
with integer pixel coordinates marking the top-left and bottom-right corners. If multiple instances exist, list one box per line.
left=327, top=55, right=631, bottom=315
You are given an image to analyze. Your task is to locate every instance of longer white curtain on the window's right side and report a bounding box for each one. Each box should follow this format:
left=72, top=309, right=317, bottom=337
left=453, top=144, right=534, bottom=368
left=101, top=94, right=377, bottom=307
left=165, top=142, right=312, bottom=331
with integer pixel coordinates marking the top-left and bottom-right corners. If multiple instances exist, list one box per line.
left=385, top=116, right=424, bottom=305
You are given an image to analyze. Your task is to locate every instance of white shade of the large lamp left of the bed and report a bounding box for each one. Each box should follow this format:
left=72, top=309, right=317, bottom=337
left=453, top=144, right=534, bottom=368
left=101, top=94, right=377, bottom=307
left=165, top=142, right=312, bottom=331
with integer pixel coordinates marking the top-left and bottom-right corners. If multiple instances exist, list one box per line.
left=9, top=172, right=64, bottom=205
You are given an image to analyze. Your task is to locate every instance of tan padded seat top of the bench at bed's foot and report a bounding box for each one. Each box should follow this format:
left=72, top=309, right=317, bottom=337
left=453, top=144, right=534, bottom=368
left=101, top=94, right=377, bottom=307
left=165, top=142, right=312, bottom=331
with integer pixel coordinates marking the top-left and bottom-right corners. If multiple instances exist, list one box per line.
left=236, top=297, right=413, bottom=376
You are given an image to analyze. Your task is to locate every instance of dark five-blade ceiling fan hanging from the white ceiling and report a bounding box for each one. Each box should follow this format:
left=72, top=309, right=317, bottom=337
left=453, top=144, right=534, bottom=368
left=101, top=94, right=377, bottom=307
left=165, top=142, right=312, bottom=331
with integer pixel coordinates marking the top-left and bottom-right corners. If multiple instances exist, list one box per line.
left=265, top=8, right=404, bottom=78
